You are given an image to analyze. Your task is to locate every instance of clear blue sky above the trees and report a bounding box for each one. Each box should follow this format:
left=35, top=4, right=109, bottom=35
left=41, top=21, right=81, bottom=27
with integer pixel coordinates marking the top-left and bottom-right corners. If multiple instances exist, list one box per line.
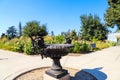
left=0, top=0, right=108, bottom=35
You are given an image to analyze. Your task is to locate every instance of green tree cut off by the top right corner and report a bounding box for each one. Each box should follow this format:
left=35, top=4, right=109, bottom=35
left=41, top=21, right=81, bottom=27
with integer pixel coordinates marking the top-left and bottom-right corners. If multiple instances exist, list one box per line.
left=105, top=0, right=120, bottom=30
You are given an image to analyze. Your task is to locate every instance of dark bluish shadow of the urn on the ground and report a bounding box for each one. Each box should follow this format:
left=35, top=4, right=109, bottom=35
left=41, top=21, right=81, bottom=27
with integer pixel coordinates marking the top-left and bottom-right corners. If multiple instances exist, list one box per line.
left=70, top=67, right=107, bottom=80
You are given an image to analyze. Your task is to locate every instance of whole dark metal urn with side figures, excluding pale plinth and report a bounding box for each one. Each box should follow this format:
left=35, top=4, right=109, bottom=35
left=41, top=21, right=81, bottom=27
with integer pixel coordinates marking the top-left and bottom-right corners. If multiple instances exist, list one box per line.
left=33, top=36, right=73, bottom=79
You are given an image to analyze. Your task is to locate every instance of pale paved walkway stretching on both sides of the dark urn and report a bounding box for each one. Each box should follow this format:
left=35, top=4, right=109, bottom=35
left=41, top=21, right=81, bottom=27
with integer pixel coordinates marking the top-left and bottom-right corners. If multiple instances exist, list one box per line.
left=0, top=46, right=120, bottom=80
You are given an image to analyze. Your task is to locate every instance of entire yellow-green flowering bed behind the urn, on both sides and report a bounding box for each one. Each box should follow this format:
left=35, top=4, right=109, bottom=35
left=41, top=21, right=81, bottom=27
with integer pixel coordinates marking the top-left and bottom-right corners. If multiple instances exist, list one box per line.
left=0, top=35, right=116, bottom=55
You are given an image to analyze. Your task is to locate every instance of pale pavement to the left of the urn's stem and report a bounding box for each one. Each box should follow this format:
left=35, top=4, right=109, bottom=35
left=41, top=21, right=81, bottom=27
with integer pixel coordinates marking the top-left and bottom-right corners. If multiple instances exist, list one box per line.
left=0, top=50, right=52, bottom=80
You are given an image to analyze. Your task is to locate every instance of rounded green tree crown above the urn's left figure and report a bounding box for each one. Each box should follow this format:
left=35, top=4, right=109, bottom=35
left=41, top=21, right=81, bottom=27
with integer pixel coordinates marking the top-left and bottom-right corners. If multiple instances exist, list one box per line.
left=23, top=21, right=48, bottom=37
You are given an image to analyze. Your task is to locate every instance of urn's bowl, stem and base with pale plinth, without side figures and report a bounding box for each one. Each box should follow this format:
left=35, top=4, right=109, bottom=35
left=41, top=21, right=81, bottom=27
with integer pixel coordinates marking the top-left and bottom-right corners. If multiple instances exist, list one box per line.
left=44, top=44, right=72, bottom=80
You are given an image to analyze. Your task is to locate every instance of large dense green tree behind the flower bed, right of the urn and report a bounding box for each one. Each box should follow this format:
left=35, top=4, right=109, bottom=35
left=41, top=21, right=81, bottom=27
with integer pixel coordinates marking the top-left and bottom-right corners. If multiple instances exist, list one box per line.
left=80, top=14, right=108, bottom=40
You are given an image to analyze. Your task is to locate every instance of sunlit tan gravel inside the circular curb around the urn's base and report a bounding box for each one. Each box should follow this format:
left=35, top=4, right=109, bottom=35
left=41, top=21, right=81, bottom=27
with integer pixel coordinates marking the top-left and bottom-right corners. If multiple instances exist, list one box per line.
left=14, top=67, right=79, bottom=80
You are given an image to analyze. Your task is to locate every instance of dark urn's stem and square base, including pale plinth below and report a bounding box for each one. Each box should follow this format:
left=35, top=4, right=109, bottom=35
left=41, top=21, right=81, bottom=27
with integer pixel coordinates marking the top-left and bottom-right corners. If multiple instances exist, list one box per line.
left=44, top=57, right=70, bottom=80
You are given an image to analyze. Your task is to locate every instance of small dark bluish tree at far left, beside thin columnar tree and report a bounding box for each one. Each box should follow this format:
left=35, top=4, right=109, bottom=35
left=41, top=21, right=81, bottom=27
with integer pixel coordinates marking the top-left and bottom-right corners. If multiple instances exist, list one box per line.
left=7, top=26, right=17, bottom=40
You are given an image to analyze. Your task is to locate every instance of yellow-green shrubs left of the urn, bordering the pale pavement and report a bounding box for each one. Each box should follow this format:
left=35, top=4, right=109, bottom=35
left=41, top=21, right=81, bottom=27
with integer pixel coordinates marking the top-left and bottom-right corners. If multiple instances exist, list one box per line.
left=0, top=37, right=33, bottom=55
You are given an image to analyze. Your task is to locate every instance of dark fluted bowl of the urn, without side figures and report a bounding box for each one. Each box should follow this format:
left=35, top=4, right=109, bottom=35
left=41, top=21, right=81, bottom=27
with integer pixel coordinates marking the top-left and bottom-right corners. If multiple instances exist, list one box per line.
left=44, top=44, right=73, bottom=57
